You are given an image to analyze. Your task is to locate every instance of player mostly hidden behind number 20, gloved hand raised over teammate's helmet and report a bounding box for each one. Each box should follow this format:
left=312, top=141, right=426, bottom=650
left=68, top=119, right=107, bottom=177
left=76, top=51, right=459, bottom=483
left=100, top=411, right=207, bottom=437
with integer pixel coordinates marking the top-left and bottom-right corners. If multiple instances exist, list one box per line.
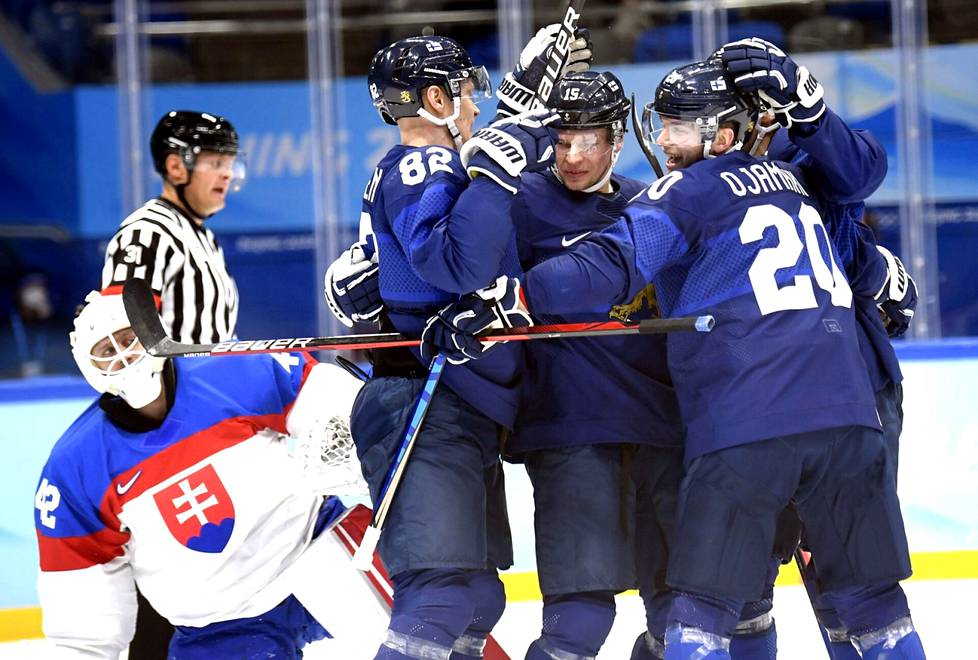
left=716, top=38, right=917, bottom=660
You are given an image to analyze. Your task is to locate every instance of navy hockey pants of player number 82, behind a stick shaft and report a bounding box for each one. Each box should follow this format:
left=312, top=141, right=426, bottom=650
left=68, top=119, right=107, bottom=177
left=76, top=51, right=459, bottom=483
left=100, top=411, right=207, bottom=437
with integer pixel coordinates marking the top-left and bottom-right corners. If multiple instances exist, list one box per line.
left=350, top=377, right=513, bottom=578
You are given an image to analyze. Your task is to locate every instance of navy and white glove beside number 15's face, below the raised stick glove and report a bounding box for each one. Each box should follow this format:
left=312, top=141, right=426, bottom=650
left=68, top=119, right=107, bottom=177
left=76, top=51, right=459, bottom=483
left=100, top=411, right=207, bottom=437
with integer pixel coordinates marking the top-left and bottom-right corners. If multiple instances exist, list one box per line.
left=459, top=110, right=560, bottom=195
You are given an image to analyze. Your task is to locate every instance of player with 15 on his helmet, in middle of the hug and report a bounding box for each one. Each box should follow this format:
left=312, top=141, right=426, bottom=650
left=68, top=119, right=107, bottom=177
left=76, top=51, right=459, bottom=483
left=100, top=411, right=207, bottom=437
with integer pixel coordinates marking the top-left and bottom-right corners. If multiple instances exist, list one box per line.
left=500, top=71, right=682, bottom=660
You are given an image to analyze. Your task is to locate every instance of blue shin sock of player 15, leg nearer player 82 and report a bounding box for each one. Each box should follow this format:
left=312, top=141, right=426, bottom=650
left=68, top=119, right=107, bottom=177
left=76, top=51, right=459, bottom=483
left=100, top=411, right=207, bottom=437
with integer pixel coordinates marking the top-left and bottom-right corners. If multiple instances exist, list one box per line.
left=526, top=591, right=615, bottom=660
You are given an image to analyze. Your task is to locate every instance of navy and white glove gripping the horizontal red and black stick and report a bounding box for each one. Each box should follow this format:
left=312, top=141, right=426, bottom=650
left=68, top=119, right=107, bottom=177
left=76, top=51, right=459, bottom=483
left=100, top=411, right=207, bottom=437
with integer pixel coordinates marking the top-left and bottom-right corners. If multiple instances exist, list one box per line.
left=421, top=275, right=533, bottom=364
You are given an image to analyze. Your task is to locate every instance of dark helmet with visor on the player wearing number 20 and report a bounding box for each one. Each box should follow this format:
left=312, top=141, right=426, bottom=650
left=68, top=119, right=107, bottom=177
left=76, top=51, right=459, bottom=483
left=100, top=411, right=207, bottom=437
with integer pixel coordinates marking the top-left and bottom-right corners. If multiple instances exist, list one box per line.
left=642, top=58, right=759, bottom=153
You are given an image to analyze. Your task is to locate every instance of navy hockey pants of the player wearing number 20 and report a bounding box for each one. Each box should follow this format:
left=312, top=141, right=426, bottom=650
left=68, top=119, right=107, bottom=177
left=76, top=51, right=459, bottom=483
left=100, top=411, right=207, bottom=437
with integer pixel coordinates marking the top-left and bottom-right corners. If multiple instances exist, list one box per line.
left=668, top=427, right=910, bottom=636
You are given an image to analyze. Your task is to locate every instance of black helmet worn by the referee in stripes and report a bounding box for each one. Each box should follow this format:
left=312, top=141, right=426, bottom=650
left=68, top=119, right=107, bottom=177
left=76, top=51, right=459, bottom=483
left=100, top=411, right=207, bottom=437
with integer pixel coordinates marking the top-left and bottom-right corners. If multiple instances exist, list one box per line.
left=149, top=110, right=239, bottom=177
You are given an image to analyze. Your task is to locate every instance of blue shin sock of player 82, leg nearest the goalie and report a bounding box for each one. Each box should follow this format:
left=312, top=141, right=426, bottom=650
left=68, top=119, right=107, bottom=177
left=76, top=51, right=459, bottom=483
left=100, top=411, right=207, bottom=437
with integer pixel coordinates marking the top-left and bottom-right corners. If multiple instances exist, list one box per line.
left=376, top=569, right=476, bottom=660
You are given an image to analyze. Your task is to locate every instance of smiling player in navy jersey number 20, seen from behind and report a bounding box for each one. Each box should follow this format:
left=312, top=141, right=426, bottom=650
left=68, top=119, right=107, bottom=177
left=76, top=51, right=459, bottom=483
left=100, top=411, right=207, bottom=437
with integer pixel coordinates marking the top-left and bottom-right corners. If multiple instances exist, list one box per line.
left=428, top=59, right=923, bottom=660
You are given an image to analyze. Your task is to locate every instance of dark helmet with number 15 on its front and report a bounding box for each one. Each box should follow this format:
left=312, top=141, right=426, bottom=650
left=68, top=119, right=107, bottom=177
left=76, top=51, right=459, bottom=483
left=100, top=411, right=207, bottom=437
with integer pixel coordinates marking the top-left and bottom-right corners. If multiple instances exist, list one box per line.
left=549, top=71, right=632, bottom=131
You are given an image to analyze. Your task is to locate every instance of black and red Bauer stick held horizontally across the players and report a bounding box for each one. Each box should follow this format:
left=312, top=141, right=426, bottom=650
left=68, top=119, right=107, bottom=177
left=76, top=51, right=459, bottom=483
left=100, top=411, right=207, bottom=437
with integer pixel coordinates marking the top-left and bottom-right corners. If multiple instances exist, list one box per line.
left=122, top=278, right=714, bottom=357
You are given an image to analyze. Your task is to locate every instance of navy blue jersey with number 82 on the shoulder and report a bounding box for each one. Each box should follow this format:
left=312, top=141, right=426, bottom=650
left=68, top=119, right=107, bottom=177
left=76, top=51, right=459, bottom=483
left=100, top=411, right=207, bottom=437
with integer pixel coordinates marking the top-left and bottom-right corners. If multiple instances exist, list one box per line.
left=361, top=145, right=523, bottom=427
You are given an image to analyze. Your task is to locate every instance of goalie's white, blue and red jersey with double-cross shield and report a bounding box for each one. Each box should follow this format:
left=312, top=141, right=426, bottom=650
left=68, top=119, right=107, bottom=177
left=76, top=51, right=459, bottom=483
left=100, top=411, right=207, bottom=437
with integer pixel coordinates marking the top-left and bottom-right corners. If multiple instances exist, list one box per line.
left=34, top=354, right=358, bottom=657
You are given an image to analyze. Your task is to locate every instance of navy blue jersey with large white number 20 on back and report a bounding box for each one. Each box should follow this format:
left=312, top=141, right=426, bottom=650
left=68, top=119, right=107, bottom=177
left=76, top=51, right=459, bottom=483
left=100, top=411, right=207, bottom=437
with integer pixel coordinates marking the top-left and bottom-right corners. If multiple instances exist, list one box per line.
left=526, top=152, right=879, bottom=460
